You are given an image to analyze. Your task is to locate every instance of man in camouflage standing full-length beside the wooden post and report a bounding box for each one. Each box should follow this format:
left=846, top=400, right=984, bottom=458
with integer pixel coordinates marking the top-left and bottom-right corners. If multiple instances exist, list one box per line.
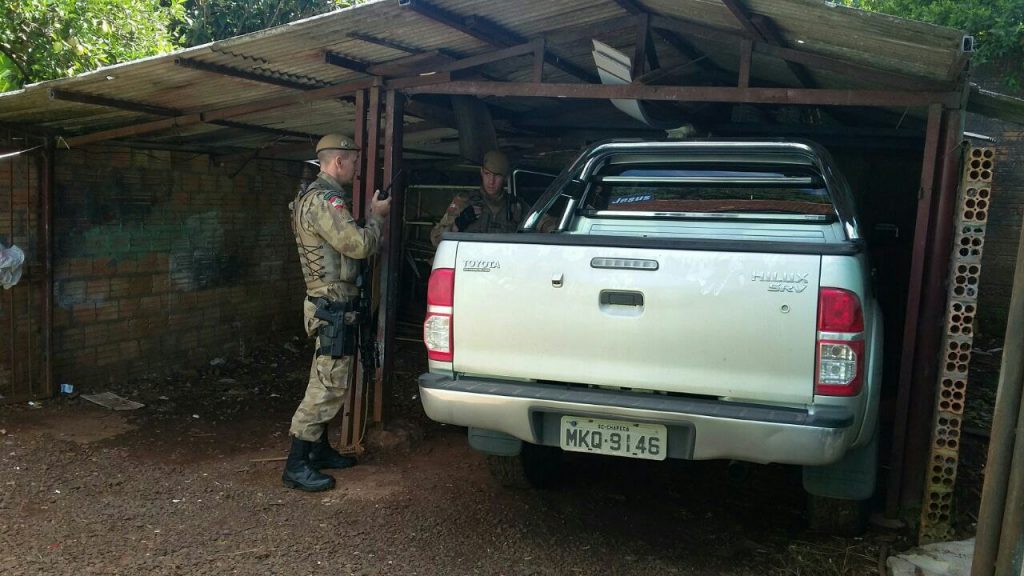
left=282, top=134, right=391, bottom=492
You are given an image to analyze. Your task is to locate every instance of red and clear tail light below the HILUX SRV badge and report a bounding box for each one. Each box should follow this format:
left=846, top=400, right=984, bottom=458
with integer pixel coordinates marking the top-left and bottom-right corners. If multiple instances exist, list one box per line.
left=814, top=288, right=864, bottom=396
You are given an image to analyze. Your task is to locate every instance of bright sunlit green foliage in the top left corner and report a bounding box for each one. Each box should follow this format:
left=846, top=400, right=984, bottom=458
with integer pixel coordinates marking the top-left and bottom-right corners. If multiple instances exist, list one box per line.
left=0, top=0, right=184, bottom=91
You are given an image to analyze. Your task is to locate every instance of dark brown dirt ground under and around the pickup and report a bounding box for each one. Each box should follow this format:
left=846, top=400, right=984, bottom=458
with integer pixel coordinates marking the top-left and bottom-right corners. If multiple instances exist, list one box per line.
left=0, top=341, right=984, bottom=576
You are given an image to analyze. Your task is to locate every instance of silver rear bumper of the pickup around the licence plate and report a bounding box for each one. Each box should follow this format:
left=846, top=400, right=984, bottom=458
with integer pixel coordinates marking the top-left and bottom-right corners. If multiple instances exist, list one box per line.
left=419, top=374, right=856, bottom=465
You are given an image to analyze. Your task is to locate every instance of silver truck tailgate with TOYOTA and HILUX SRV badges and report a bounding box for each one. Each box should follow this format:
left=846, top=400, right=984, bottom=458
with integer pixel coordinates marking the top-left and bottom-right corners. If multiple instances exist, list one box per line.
left=453, top=242, right=821, bottom=404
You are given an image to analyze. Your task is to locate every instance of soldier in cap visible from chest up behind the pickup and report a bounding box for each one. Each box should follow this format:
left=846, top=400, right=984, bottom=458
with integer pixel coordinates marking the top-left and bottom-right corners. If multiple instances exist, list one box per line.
left=430, top=150, right=529, bottom=247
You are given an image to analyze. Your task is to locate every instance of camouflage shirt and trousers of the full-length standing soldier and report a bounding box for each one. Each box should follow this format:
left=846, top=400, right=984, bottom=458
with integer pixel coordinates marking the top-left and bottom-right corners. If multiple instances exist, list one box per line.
left=290, top=172, right=382, bottom=442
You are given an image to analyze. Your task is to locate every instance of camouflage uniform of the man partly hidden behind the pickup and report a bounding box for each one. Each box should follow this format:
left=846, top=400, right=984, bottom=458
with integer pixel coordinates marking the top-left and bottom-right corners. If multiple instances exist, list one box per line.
left=430, top=190, right=529, bottom=246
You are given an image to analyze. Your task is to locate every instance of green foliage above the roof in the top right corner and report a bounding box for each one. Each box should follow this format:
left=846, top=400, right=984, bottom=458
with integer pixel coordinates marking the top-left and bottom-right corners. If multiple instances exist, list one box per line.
left=841, top=0, right=1024, bottom=87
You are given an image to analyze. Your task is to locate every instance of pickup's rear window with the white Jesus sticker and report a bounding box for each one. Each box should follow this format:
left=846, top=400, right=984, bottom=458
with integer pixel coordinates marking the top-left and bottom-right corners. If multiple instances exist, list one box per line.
left=584, top=164, right=835, bottom=216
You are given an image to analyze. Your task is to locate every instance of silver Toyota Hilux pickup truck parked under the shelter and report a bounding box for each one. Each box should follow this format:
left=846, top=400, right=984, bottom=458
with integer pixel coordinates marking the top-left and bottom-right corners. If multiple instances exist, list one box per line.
left=419, top=140, right=883, bottom=532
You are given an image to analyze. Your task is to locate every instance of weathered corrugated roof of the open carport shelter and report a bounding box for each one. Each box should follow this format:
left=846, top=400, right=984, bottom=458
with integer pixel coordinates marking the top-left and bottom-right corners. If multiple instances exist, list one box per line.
left=0, top=0, right=999, bottom=156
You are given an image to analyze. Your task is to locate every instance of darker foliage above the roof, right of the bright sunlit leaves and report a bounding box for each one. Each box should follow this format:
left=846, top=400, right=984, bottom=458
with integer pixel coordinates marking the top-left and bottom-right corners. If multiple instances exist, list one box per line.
left=175, top=0, right=366, bottom=46
